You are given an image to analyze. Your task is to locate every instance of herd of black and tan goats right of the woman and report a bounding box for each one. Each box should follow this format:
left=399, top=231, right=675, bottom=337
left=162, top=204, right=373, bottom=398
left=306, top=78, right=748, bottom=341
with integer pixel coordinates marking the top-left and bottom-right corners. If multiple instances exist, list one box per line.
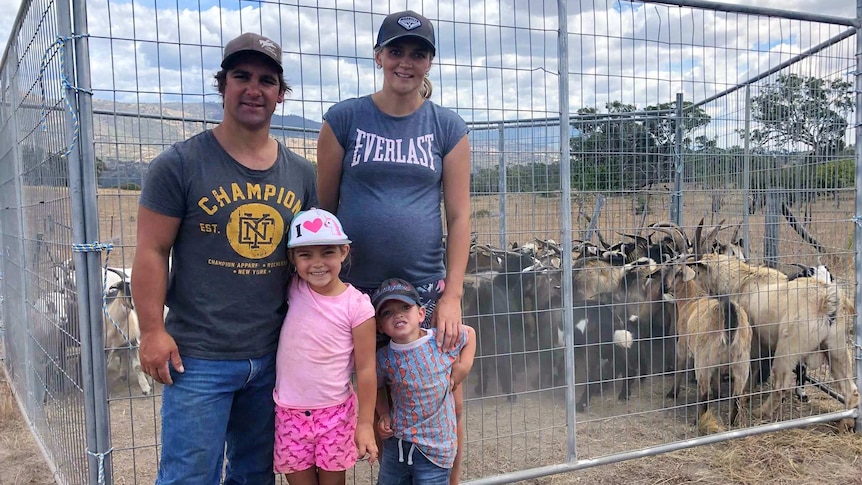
left=462, top=220, right=859, bottom=434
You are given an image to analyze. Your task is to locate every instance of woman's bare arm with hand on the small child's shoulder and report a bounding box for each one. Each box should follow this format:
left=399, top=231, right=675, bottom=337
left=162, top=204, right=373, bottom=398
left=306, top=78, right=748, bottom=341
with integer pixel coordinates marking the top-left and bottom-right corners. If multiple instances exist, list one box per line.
left=438, top=135, right=470, bottom=350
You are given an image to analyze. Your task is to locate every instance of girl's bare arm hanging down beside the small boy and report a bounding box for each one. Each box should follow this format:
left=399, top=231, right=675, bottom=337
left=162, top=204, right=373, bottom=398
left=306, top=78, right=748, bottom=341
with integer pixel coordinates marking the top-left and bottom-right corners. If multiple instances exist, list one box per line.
left=353, top=317, right=378, bottom=462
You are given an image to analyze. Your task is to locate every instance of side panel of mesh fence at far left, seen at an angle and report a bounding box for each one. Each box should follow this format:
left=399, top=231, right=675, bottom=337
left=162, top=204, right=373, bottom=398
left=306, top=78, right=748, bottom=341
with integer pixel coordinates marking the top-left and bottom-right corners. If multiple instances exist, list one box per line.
left=0, top=1, right=89, bottom=483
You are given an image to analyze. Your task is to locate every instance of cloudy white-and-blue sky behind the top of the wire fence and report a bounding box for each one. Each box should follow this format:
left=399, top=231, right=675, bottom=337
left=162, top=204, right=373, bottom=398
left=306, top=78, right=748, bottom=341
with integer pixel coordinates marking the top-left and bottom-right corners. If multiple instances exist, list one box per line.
left=0, top=0, right=855, bottom=134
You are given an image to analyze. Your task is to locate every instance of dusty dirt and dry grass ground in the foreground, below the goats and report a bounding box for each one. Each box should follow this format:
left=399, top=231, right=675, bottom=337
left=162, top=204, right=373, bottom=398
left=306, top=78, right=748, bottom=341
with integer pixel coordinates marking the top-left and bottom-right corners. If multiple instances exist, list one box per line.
left=0, top=352, right=862, bottom=485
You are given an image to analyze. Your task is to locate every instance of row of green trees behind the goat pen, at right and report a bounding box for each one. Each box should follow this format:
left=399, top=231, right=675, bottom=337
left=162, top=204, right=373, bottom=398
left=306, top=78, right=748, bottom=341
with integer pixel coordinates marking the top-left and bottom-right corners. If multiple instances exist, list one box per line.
left=471, top=74, right=855, bottom=194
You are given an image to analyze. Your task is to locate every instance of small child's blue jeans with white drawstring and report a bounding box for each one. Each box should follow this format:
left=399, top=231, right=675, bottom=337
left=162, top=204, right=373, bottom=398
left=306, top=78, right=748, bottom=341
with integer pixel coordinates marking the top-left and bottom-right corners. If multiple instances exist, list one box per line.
left=377, top=438, right=451, bottom=485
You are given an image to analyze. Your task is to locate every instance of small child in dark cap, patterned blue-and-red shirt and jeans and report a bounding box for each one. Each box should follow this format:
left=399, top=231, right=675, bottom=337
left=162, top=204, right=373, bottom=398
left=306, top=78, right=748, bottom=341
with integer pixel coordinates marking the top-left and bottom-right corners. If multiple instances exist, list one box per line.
left=371, top=278, right=476, bottom=485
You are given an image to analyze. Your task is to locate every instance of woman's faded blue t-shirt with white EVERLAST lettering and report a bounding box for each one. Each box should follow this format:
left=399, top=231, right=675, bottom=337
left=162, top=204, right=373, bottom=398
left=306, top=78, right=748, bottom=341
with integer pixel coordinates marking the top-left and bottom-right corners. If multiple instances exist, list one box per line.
left=323, top=96, right=468, bottom=288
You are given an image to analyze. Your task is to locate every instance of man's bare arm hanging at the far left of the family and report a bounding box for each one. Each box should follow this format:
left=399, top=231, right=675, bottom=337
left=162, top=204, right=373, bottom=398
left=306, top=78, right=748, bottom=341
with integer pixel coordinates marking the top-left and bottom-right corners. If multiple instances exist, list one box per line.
left=132, top=206, right=184, bottom=384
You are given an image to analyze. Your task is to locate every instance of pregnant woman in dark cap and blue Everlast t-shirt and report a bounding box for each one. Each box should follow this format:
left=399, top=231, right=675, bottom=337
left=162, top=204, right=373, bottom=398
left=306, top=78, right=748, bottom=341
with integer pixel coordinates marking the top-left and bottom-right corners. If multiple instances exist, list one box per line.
left=317, top=11, right=470, bottom=483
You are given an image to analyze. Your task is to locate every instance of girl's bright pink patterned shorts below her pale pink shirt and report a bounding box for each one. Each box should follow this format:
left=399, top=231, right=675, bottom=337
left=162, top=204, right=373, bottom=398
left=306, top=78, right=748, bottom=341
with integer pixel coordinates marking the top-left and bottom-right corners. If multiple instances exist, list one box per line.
left=273, top=393, right=357, bottom=473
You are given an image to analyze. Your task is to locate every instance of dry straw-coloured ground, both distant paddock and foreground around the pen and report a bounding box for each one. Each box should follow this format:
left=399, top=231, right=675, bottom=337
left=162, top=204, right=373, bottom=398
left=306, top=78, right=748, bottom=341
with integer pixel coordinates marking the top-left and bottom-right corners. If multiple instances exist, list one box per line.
left=6, top=188, right=862, bottom=485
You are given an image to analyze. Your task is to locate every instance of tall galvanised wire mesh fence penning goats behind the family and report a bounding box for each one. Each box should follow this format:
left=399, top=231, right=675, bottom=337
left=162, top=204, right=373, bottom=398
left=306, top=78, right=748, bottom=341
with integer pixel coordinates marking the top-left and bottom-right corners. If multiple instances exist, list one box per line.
left=0, top=0, right=860, bottom=483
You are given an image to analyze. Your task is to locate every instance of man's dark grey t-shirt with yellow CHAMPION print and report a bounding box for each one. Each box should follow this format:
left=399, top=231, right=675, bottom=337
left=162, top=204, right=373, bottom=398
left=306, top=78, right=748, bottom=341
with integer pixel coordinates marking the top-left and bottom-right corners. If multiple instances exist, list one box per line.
left=140, top=131, right=317, bottom=359
